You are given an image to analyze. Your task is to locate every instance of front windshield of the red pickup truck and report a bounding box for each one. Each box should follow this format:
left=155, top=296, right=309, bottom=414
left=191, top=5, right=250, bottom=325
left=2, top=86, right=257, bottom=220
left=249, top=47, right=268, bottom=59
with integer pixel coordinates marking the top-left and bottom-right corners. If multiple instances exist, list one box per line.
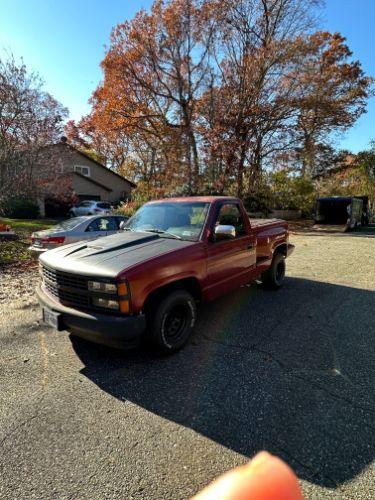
left=125, top=202, right=209, bottom=241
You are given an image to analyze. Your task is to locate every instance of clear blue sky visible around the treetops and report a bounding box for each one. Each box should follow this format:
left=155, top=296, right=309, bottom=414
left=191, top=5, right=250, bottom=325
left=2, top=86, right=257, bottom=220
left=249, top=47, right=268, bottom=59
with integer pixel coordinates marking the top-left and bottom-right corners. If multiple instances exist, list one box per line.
left=0, top=0, right=375, bottom=151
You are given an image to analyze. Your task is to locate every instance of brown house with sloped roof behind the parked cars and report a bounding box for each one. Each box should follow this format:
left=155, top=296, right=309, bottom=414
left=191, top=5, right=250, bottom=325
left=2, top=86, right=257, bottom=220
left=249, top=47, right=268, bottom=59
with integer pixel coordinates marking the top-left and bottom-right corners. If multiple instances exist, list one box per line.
left=35, top=137, right=135, bottom=216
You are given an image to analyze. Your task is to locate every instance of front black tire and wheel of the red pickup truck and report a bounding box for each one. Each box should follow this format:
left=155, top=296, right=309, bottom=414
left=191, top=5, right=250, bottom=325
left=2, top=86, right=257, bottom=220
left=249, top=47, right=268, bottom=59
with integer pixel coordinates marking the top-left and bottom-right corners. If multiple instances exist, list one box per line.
left=148, top=290, right=197, bottom=354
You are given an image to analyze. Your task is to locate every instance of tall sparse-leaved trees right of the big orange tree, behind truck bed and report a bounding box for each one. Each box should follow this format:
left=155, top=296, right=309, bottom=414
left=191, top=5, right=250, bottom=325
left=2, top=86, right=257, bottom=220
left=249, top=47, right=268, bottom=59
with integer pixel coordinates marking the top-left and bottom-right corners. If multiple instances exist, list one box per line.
left=198, top=0, right=324, bottom=196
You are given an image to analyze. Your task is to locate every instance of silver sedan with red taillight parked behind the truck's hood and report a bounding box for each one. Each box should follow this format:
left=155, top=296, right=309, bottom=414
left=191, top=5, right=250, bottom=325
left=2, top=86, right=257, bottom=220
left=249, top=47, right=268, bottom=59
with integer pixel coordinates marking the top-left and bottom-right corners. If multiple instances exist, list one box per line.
left=29, top=215, right=127, bottom=257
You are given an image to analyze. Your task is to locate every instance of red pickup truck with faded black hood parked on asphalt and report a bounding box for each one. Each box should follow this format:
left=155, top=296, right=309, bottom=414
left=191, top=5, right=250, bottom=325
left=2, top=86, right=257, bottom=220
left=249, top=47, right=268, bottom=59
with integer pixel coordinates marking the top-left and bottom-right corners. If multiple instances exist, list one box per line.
left=37, top=196, right=294, bottom=353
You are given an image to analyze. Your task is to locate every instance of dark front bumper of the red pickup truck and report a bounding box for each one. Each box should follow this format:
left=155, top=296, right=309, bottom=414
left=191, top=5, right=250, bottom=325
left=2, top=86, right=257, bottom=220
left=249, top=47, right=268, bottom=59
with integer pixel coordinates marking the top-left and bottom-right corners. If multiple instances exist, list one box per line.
left=36, top=285, right=146, bottom=349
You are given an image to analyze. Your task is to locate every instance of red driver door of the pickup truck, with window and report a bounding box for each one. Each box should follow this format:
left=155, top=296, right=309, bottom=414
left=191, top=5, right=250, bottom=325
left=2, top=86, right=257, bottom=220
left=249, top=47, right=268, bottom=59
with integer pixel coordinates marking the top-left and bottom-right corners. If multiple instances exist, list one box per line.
left=207, top=202, right=256, bottom=299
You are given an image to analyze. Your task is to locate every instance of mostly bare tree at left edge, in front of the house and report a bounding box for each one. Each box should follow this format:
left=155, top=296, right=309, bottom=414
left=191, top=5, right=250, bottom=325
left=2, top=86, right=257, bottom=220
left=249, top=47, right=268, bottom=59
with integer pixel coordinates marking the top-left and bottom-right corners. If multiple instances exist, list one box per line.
left=0, top=57, right=67, bottom=210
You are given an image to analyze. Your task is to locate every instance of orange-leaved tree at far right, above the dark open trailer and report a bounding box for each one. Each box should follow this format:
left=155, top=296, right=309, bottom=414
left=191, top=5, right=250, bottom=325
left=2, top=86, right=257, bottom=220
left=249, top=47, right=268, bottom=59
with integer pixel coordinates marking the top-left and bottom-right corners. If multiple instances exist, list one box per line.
left=293, top=32, right=373, bottom=176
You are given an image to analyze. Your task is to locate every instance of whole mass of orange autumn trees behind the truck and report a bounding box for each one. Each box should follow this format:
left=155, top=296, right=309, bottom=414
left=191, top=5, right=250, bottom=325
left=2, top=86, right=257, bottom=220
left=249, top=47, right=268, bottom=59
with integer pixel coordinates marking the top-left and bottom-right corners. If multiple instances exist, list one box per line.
left=67, top=0, right=372, bottom=203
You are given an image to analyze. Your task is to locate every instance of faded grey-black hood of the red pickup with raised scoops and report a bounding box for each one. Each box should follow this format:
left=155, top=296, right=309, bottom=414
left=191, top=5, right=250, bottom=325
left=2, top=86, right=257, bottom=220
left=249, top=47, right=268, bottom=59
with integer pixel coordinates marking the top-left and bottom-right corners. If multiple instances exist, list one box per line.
left=39, top=231, right=194, bottom=278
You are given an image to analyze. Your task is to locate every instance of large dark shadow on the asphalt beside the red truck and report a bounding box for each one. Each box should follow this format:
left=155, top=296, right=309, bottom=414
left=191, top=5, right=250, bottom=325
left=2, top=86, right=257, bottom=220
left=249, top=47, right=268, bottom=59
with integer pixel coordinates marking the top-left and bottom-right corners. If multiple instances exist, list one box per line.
left=72, top=278, right=375, bottom=488
